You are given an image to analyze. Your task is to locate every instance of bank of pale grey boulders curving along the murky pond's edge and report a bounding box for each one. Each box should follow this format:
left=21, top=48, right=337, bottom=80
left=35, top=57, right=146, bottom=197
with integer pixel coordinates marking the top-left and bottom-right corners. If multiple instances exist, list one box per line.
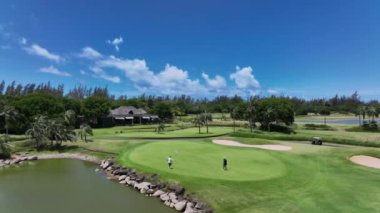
left=0, top=153, right=213, bottom=213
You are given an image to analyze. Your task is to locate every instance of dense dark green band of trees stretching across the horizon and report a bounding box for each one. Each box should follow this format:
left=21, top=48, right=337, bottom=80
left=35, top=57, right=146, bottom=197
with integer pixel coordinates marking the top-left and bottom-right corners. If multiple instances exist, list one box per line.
left=0, top=81, right=379, bottom=133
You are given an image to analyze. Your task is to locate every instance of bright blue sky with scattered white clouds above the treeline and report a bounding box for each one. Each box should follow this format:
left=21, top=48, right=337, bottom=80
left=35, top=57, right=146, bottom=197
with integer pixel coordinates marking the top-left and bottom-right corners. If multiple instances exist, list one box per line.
left=0, top=0, right=380, bottom=99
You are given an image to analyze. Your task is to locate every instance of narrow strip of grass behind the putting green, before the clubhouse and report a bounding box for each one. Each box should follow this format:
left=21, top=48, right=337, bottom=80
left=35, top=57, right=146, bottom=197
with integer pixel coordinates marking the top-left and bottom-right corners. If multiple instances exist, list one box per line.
left=94, top=127, right=233, bottom=139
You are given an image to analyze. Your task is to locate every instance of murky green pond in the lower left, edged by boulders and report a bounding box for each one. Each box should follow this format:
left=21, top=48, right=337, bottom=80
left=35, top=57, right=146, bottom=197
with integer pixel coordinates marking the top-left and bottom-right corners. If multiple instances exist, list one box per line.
left=0, top=159, right=175, bottom=213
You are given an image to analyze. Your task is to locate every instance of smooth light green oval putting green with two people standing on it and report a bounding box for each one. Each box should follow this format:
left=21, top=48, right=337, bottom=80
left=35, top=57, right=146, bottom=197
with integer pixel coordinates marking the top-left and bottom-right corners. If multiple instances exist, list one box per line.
left=121, top=142, right=286, bottom=181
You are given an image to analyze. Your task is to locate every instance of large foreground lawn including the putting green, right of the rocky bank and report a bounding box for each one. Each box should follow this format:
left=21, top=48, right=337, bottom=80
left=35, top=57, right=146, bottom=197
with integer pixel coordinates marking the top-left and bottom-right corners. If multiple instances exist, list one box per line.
left=119, top=138, right=380, bottom=212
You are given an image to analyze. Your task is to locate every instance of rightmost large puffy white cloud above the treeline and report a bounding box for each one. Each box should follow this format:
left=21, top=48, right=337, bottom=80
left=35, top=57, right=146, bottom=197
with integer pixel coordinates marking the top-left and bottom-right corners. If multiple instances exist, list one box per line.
left=230, top=66, right=260, bottom=90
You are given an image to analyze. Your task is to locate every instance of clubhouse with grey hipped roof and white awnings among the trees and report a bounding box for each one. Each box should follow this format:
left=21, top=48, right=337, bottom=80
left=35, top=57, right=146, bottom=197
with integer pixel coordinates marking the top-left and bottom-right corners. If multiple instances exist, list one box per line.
left=110, top=106, right=160, bottom=126
